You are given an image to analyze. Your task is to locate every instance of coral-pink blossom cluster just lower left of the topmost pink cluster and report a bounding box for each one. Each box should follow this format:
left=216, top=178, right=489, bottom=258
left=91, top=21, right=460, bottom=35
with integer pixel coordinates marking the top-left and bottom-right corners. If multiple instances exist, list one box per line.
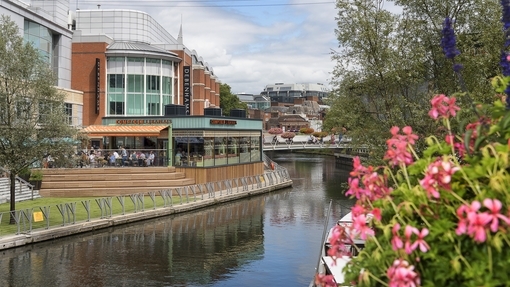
left=384, top=126, right=418, bottom=169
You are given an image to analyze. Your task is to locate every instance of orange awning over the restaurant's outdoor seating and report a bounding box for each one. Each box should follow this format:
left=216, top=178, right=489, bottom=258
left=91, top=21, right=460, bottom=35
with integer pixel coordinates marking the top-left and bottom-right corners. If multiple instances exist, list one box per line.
left=81, top=125, right=168, bottom=138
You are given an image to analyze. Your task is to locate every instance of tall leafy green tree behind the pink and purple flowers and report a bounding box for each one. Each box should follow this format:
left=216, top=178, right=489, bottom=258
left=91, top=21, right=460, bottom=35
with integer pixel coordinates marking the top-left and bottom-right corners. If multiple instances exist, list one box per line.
left=323, top=0, right=504, bottom=165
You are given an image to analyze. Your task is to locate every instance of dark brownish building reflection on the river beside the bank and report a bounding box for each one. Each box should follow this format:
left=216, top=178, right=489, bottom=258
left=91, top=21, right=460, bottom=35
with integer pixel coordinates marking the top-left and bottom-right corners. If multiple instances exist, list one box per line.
left=0, top=197, right=264, bottom=286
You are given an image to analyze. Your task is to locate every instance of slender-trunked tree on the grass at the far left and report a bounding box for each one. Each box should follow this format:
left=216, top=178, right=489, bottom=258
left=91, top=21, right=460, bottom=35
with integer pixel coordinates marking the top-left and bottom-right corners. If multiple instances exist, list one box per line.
left=0, top=15, right=76, bottom=220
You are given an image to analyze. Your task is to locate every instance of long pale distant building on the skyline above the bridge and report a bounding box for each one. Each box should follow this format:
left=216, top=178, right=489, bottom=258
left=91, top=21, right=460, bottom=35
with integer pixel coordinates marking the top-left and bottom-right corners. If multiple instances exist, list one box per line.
left=260, top=83, right=330, bottom=104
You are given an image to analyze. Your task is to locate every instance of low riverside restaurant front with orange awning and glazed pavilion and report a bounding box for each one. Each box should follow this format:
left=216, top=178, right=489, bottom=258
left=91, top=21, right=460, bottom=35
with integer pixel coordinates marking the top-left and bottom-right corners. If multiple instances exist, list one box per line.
left=83, top=116, right=262, bottom=168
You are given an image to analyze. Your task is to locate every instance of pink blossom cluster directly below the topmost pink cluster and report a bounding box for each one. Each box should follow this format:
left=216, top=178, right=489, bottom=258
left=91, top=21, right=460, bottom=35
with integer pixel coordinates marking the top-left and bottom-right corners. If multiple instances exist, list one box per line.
left=420, top=158, right=460, bottom=198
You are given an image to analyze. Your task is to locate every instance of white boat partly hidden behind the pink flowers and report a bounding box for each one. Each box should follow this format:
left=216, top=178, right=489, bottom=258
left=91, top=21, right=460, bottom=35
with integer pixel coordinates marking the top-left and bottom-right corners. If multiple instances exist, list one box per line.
left=310, top=207, right=365, bottom=287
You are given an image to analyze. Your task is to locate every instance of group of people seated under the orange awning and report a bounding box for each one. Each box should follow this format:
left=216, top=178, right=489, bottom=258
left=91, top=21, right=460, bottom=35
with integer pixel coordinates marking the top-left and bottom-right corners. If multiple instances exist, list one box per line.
left=79, top=147, right=156, bottom=167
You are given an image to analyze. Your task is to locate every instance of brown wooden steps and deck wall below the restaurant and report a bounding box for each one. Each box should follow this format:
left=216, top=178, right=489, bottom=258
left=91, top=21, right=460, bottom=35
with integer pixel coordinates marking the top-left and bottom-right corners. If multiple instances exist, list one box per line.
left=39, top=162, right=264, bottom=197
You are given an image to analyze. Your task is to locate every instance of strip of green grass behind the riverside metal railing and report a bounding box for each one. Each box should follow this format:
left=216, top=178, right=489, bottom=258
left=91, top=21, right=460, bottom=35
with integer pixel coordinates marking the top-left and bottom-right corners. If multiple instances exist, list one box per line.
left=0, top=195, right=195, bottom=237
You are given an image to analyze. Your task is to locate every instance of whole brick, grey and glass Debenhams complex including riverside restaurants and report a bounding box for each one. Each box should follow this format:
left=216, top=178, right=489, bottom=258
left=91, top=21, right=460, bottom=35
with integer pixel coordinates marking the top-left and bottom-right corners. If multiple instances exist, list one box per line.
left=0, top=0, right=263, bottom=179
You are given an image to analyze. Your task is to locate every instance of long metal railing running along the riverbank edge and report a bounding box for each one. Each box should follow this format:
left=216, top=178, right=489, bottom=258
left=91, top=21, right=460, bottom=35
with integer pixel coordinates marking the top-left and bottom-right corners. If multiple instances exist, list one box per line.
left=0, top=168, right=290, bottom=238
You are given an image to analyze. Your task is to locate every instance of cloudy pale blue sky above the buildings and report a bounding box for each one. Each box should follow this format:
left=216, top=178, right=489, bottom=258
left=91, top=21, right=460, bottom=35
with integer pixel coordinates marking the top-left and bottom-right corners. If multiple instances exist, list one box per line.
left=70, top=0, right=400, bottom=95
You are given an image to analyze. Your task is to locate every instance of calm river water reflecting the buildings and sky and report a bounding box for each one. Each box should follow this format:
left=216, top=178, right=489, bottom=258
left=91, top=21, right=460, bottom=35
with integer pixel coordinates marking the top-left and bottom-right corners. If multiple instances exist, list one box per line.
left=0, top=152, right=353, bottom=287
